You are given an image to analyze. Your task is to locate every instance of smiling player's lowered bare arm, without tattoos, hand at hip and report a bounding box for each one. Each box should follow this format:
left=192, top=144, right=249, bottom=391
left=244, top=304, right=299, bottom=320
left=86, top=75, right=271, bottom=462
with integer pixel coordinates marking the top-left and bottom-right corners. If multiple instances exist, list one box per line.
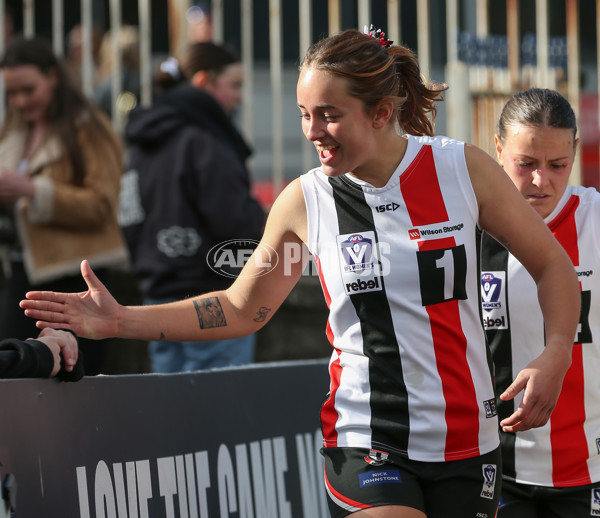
left=465, top=146, right=581, bottom=431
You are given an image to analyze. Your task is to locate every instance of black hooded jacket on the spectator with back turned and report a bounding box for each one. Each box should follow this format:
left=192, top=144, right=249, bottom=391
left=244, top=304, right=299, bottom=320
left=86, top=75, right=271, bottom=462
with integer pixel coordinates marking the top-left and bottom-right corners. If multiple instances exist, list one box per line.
left=120, top=84, right=265, bottom=298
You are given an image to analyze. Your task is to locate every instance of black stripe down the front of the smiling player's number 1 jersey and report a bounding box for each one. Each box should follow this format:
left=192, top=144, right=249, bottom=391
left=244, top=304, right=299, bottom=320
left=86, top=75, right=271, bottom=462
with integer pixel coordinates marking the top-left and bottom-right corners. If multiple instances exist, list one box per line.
left=329, top=177, right=410, bottom=455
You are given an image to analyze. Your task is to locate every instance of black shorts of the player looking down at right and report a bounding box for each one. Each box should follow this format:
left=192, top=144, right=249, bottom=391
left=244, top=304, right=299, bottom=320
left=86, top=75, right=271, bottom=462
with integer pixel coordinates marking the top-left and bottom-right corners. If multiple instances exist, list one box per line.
left=498, top=479, right=600, bottom=518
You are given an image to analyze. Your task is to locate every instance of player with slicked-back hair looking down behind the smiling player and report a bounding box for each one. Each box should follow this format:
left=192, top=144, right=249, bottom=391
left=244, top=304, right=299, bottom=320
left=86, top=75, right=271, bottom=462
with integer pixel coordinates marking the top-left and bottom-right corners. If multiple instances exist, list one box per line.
left=481, top=88, right=600, bottom=518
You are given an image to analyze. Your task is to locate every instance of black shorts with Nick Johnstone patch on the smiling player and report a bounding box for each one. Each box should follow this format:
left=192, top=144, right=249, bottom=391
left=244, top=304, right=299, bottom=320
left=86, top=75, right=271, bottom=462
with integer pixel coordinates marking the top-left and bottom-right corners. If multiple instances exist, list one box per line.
left=321, top=448, right=502, bottom=518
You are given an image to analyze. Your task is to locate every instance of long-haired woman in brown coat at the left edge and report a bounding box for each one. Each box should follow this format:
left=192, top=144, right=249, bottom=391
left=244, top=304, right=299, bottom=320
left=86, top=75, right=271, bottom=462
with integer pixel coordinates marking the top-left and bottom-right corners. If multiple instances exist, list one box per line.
left=0, top=38, right=127, bottom=374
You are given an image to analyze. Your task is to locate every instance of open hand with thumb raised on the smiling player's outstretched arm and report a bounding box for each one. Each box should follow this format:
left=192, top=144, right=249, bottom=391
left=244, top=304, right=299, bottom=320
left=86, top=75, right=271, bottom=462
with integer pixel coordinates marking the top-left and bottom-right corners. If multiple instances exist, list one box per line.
left=19, top=260, right=121, bottom=339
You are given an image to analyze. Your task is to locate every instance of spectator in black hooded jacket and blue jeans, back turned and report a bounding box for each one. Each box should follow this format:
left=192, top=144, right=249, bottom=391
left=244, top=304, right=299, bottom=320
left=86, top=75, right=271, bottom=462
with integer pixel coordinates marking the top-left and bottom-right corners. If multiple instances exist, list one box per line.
left=120, top=42, right=265, bottom=372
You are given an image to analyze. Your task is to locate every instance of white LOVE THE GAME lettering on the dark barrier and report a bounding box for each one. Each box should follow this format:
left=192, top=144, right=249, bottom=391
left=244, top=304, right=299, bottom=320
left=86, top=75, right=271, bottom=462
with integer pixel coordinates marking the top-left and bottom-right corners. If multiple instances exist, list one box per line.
left=76, top=430, right=327, bottom=518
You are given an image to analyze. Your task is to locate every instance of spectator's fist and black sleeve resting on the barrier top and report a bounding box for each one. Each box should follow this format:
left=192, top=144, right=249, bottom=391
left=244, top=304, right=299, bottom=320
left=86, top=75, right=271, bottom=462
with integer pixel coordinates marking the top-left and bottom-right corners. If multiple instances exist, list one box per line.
left=0, top=328, right=83, bottom=381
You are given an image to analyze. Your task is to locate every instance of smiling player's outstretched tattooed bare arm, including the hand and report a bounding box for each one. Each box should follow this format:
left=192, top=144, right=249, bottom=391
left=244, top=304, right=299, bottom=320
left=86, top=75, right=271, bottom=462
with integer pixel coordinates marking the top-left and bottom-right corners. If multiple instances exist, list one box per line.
left=21, top=180, right=306, bottom=341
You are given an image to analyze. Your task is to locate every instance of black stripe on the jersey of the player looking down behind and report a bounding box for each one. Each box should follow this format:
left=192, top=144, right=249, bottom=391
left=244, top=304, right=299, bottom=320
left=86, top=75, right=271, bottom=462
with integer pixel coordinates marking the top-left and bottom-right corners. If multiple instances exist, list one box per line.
left=481, top=232, right=516, bottom=479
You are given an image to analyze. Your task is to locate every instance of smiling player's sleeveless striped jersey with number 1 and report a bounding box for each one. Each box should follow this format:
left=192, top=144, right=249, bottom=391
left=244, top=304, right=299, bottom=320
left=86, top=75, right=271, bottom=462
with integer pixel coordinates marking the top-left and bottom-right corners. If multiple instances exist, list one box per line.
left=301, top=136, right=499, bottom=461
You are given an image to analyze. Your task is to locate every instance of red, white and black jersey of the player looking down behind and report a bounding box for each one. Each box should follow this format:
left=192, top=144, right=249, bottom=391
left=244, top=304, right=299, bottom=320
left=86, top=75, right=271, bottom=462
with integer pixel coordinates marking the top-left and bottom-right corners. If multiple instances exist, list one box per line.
left=481, top=186, right=600, bottom=487
